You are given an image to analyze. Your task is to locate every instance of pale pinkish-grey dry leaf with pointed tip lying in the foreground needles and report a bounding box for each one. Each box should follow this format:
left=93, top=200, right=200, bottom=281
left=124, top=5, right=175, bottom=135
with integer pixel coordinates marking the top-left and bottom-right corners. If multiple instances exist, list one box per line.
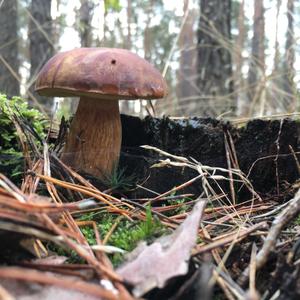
left=117, top=201, right=206, bottom=297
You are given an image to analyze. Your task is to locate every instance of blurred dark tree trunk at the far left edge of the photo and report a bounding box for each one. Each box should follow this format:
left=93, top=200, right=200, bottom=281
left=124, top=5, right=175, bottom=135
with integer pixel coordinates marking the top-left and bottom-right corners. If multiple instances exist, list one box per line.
left=0, top=0, right=20, bottom=97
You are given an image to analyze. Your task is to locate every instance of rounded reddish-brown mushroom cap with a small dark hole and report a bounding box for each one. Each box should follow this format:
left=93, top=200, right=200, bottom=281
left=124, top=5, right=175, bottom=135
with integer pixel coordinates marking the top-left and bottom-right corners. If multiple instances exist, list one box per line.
left=35, top=48, right=167, bottom=100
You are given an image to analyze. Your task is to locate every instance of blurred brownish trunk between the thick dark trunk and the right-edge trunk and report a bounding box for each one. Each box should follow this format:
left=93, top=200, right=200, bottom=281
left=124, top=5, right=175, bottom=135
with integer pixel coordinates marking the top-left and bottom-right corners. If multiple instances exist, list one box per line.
left=248, top=0, right=265, bottom=114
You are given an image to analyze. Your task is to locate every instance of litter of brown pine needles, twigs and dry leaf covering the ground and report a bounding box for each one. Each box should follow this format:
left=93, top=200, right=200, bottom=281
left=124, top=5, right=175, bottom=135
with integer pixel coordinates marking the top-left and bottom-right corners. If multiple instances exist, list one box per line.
left=0, top=104, right=300, bottom=300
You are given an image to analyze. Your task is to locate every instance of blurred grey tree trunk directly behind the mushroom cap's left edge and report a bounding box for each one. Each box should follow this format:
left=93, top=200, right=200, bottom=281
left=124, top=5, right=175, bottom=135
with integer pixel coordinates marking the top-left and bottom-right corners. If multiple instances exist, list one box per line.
left=29, top=0, right=54, bottom=114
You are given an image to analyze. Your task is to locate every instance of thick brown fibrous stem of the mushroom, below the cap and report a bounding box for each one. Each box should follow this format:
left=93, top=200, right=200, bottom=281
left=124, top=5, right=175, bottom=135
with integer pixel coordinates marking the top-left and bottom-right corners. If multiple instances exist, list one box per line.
left=62, top=97, right=122, bottom=178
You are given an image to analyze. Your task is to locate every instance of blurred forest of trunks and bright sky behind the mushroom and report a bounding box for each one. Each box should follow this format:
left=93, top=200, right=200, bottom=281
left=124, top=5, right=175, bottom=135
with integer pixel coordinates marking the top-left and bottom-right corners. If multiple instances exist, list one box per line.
left=0, top=0, right=300, bottom=118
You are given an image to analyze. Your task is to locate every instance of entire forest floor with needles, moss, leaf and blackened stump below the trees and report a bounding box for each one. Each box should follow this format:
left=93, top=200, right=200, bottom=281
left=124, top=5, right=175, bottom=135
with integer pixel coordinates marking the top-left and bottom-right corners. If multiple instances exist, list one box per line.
left=0, top=116, right=300, bottom=300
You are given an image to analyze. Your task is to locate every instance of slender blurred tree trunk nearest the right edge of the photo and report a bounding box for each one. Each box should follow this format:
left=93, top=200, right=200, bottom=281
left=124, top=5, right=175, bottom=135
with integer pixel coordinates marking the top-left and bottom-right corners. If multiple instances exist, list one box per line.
left=283, top=0, right=297, bottom=112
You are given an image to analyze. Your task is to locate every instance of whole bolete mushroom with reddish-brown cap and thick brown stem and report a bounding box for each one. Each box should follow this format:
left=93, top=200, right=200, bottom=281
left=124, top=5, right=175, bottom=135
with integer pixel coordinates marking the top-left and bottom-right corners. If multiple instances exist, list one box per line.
left=35, top=48, right=167, bottom=177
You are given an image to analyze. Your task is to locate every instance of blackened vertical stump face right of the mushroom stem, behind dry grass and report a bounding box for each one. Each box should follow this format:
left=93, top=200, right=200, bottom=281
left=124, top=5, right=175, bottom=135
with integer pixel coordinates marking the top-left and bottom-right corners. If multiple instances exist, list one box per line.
left=120, top=115, right=300, bottom=201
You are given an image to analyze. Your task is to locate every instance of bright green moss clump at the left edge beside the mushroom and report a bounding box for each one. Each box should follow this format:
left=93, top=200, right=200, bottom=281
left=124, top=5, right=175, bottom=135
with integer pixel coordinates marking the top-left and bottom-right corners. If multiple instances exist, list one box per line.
left=0, top=94, right=46, bottom=181
